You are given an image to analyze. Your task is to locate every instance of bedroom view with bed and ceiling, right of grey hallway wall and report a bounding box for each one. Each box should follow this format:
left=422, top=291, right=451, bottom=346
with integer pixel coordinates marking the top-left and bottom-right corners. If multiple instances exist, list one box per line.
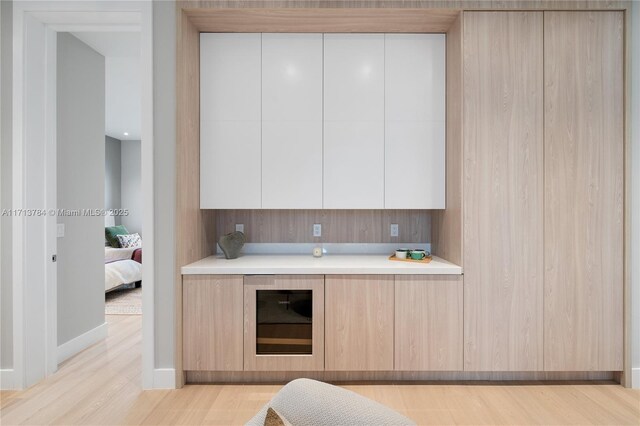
left=93, top=32, right=144, bottom=322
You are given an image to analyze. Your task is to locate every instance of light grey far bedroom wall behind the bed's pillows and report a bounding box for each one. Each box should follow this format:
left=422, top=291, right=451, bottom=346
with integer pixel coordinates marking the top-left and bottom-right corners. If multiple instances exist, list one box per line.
left=120, top=141, right=144, bottom=235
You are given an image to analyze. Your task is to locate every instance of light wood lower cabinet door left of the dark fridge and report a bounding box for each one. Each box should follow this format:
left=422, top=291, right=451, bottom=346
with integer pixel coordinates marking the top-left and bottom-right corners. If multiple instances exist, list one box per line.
left=182, top=275, right=243, bottom=371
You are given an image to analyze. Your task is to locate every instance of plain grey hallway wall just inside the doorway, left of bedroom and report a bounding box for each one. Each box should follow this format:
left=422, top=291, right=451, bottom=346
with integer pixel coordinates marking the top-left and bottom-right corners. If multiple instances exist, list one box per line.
left=57, top=33, right=105, bottom=346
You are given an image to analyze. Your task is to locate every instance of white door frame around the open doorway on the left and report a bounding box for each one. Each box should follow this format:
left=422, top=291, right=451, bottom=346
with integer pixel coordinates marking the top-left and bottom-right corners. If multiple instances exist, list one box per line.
left=10, top=1, right=157, bottom=389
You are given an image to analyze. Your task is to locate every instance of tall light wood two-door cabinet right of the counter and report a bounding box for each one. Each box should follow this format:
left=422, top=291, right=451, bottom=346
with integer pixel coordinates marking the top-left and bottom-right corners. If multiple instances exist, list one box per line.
left=462, top=11, right=624, bottom=371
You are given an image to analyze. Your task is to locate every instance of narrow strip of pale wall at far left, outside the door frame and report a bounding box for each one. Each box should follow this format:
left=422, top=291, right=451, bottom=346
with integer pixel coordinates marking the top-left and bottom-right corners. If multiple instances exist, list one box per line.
left=0, top=1, right=13, bottom=369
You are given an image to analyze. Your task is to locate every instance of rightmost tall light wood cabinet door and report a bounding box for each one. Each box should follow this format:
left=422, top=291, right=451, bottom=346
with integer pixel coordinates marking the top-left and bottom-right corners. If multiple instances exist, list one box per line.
left=544, top=12, right=624, bottom=371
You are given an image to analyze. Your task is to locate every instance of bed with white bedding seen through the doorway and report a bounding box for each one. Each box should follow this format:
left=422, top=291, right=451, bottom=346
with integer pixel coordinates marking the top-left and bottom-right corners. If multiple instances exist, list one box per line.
left=104, top=217, right=142, bottom=292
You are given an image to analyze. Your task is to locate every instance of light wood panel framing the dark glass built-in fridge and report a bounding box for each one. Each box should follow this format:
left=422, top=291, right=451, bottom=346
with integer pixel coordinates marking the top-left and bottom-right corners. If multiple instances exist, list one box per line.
left=244, top=275, right=325, bottom=371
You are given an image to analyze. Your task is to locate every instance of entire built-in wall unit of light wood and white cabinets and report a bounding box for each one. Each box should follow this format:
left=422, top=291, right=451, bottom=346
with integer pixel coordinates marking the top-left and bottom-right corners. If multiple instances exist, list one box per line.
left=182, top=3, right=628, bottom=380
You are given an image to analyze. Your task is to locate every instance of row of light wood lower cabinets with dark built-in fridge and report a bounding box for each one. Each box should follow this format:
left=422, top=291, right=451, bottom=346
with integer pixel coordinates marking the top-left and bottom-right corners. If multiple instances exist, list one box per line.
left=183, top=274, right=463, bottom=371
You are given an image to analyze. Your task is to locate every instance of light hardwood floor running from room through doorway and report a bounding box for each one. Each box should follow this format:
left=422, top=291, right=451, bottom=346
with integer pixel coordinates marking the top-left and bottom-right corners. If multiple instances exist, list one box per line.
left=0, top=315, right=640, bottom=426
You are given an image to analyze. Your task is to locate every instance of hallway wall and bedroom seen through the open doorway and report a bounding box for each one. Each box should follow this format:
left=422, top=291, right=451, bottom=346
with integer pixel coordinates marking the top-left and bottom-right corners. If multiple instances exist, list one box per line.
left=56, top=31, right=144, bottom=370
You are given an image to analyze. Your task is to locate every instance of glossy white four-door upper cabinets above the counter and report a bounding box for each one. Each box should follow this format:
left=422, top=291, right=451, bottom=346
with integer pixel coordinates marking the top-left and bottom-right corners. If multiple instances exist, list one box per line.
left=200, top=33, right=445, bottom=209
